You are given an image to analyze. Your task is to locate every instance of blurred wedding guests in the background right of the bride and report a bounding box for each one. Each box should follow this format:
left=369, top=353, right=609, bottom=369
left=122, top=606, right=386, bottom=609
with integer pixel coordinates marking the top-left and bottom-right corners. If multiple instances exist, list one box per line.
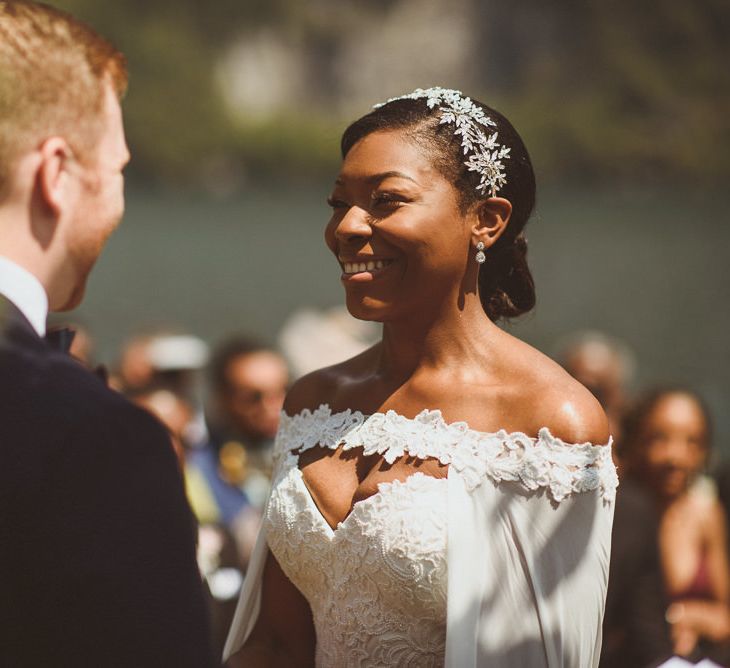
left=558, top=333, right=730, bottom=668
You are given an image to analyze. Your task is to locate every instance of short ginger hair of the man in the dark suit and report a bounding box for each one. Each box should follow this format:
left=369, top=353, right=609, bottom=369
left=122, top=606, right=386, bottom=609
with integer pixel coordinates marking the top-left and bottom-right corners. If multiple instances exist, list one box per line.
left=0, top=0, right=127, bottom=202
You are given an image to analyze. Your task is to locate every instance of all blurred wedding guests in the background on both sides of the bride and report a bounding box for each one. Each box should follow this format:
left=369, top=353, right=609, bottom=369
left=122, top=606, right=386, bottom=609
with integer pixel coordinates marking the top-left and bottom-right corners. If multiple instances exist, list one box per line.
left=59, top=318, right=730, bottom=668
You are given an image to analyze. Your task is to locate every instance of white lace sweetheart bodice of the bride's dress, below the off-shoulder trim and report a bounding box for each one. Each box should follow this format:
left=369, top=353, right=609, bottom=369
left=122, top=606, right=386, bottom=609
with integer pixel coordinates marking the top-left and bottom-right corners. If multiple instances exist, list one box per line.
left=264, top=467, right=448, bottom=668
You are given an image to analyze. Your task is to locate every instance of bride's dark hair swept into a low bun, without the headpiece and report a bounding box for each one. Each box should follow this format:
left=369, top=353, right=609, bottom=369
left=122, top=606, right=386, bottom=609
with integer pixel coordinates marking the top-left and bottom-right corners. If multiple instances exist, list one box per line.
left=340, top=99, right=535, bottom=321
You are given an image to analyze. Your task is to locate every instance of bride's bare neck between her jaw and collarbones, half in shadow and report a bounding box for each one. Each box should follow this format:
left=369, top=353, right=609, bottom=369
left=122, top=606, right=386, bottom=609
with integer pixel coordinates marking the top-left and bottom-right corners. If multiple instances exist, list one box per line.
left=379, top=294, right=498, bottom=378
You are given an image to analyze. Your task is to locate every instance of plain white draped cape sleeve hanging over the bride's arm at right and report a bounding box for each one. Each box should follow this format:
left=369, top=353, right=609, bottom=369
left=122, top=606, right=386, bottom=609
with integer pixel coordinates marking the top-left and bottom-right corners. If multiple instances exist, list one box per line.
left=445, top=440, right=615, bottom=668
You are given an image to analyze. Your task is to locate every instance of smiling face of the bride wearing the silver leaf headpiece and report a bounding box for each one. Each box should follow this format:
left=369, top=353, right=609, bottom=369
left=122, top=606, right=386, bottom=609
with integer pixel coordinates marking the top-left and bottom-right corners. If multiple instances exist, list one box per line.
left=325, top=131, right=476, bottom=322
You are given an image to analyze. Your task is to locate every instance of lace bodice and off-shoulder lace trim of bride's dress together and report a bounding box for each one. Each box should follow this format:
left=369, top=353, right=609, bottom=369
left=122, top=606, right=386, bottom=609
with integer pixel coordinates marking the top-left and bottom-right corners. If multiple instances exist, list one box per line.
left=263, top=406, right=616, bottom=668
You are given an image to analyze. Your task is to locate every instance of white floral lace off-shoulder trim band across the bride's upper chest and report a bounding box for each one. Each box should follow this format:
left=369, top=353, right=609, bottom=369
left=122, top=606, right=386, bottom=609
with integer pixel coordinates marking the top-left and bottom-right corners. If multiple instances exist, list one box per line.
left=275, top=404, right=618, bottom=502
